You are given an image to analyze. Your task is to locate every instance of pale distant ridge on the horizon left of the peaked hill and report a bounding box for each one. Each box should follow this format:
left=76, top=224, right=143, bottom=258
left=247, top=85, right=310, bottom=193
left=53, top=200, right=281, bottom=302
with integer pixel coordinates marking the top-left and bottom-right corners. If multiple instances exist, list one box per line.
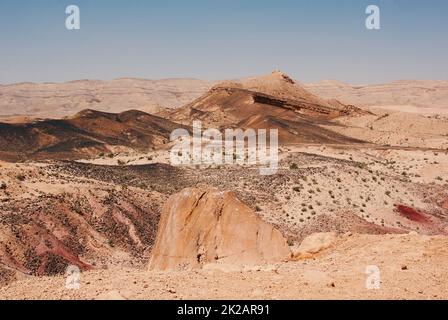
left=0, top=78, right=214, bottom=119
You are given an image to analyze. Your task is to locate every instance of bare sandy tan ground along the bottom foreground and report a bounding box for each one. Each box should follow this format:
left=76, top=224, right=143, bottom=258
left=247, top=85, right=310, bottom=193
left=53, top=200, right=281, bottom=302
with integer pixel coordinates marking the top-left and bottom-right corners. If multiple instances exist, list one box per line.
left=0, top=234, right=448, bottom=300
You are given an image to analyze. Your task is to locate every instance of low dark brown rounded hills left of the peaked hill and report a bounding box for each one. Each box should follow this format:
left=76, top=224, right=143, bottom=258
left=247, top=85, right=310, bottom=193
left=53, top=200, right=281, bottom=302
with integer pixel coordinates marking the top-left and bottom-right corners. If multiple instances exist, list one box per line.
left=0, top=110, right=187, bottom=161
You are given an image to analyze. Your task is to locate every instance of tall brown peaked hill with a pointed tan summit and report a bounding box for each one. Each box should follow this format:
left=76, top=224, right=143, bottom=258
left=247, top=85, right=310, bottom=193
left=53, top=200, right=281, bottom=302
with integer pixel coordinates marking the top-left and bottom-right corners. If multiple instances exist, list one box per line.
left=168, top=72, right=368, bottom=143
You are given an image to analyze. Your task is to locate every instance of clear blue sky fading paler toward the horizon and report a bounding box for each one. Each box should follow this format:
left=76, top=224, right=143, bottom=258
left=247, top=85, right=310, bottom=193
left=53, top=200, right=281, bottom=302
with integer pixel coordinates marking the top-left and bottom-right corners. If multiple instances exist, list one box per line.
left=0, top=0, right=448, bottom=84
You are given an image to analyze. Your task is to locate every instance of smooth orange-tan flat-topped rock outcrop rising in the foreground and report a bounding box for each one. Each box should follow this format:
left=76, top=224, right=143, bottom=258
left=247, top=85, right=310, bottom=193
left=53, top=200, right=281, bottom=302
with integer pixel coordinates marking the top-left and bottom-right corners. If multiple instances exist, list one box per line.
left=149, top=188, right=291, bottom=271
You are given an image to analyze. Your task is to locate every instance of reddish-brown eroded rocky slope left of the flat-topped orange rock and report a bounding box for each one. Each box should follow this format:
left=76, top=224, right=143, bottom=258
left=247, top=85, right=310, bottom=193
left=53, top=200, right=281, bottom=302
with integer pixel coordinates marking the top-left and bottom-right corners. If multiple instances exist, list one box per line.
left=0, top=163, right=164, bottom=284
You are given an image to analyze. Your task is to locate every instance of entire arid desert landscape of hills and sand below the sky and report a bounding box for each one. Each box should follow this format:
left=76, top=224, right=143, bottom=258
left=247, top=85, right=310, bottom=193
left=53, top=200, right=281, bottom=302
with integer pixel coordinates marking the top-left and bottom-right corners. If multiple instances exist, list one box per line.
left=0, top=71, right=448, bottom=300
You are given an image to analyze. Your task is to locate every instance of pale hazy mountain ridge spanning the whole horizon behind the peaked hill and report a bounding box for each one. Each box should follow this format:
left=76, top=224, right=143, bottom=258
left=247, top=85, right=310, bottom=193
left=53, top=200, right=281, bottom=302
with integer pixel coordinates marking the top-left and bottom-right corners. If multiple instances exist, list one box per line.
left=0, top=72, right=448, bottom=121
